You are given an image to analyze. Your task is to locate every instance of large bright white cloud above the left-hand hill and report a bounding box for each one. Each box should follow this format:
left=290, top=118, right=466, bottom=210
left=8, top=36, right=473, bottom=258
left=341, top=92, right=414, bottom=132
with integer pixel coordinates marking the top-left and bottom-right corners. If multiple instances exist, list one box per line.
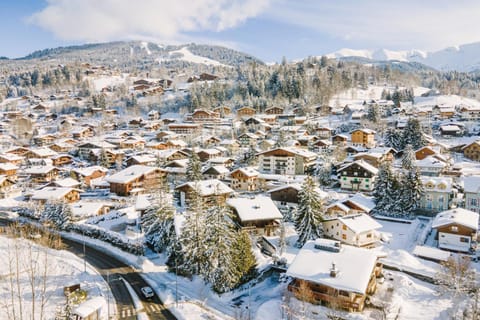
left=28, top=0, right=270, bottom=42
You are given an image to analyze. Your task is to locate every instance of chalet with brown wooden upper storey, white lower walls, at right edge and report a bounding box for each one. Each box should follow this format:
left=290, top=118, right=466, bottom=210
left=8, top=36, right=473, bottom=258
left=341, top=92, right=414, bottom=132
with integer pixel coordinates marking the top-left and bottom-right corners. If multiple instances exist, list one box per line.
left=432, top=208, right=478, bottom=253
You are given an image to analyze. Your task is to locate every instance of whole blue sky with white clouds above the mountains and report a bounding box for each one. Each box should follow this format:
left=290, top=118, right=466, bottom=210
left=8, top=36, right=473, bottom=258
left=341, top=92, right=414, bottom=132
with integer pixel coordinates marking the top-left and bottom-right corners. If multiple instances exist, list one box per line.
left=0, top=0, right=480, bottom=62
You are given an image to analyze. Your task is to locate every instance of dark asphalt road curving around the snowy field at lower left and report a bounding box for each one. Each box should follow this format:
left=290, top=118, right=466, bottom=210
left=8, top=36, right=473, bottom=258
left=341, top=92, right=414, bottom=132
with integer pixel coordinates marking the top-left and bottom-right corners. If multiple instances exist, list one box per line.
left=0, top=218, right=176, bottom=320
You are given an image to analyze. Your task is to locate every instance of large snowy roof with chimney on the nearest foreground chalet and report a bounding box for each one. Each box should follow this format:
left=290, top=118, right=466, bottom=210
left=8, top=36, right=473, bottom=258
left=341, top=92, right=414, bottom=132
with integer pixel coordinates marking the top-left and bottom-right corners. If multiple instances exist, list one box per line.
left=287, top=239, right=377, bottom=294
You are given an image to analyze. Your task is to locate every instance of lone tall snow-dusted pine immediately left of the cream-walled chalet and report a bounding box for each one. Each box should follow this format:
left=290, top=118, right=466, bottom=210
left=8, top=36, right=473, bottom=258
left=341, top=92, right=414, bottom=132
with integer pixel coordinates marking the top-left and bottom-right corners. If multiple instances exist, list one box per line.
left=295, top=176, right=323, bottom=247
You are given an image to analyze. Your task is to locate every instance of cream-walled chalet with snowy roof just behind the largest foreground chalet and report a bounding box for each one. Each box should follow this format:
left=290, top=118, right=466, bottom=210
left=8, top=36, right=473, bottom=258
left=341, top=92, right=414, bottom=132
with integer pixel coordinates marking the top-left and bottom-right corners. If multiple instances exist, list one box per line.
left=322, top=214, right=382, bottom=247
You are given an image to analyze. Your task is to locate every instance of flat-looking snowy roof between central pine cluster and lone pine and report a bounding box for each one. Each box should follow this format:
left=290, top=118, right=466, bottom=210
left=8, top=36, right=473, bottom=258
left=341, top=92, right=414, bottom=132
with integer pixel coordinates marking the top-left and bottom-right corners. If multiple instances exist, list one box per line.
left=227, top=196, right=283, bottom=222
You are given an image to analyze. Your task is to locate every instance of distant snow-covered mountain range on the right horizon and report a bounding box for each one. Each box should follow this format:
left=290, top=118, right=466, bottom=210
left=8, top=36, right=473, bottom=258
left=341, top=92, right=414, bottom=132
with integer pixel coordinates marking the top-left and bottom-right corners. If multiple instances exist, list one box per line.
left=327, top=42, right=480, bottom=72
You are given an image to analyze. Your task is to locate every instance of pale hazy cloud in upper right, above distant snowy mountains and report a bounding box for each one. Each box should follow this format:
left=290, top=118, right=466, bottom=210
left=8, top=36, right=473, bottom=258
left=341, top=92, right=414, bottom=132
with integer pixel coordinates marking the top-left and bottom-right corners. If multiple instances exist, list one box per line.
left=269, top=0, right=480, bottom=50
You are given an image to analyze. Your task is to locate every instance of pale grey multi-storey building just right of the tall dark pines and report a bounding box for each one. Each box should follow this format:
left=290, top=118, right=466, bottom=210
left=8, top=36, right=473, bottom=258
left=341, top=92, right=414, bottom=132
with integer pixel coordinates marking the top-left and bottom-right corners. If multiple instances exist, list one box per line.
left=420, top=177, right=454, bottom=213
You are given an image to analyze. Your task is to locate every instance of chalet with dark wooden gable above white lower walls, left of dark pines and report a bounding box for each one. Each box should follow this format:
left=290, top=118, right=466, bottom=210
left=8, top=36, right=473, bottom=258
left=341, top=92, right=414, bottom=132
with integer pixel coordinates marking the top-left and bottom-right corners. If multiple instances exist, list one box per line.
left=337, top=160, right=378, bottom=192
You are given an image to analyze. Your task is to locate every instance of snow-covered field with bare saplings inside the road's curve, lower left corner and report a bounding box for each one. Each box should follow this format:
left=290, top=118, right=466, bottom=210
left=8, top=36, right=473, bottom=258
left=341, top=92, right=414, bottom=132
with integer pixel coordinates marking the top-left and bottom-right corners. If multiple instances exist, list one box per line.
left=0, top=235, right=113, bottom=319
